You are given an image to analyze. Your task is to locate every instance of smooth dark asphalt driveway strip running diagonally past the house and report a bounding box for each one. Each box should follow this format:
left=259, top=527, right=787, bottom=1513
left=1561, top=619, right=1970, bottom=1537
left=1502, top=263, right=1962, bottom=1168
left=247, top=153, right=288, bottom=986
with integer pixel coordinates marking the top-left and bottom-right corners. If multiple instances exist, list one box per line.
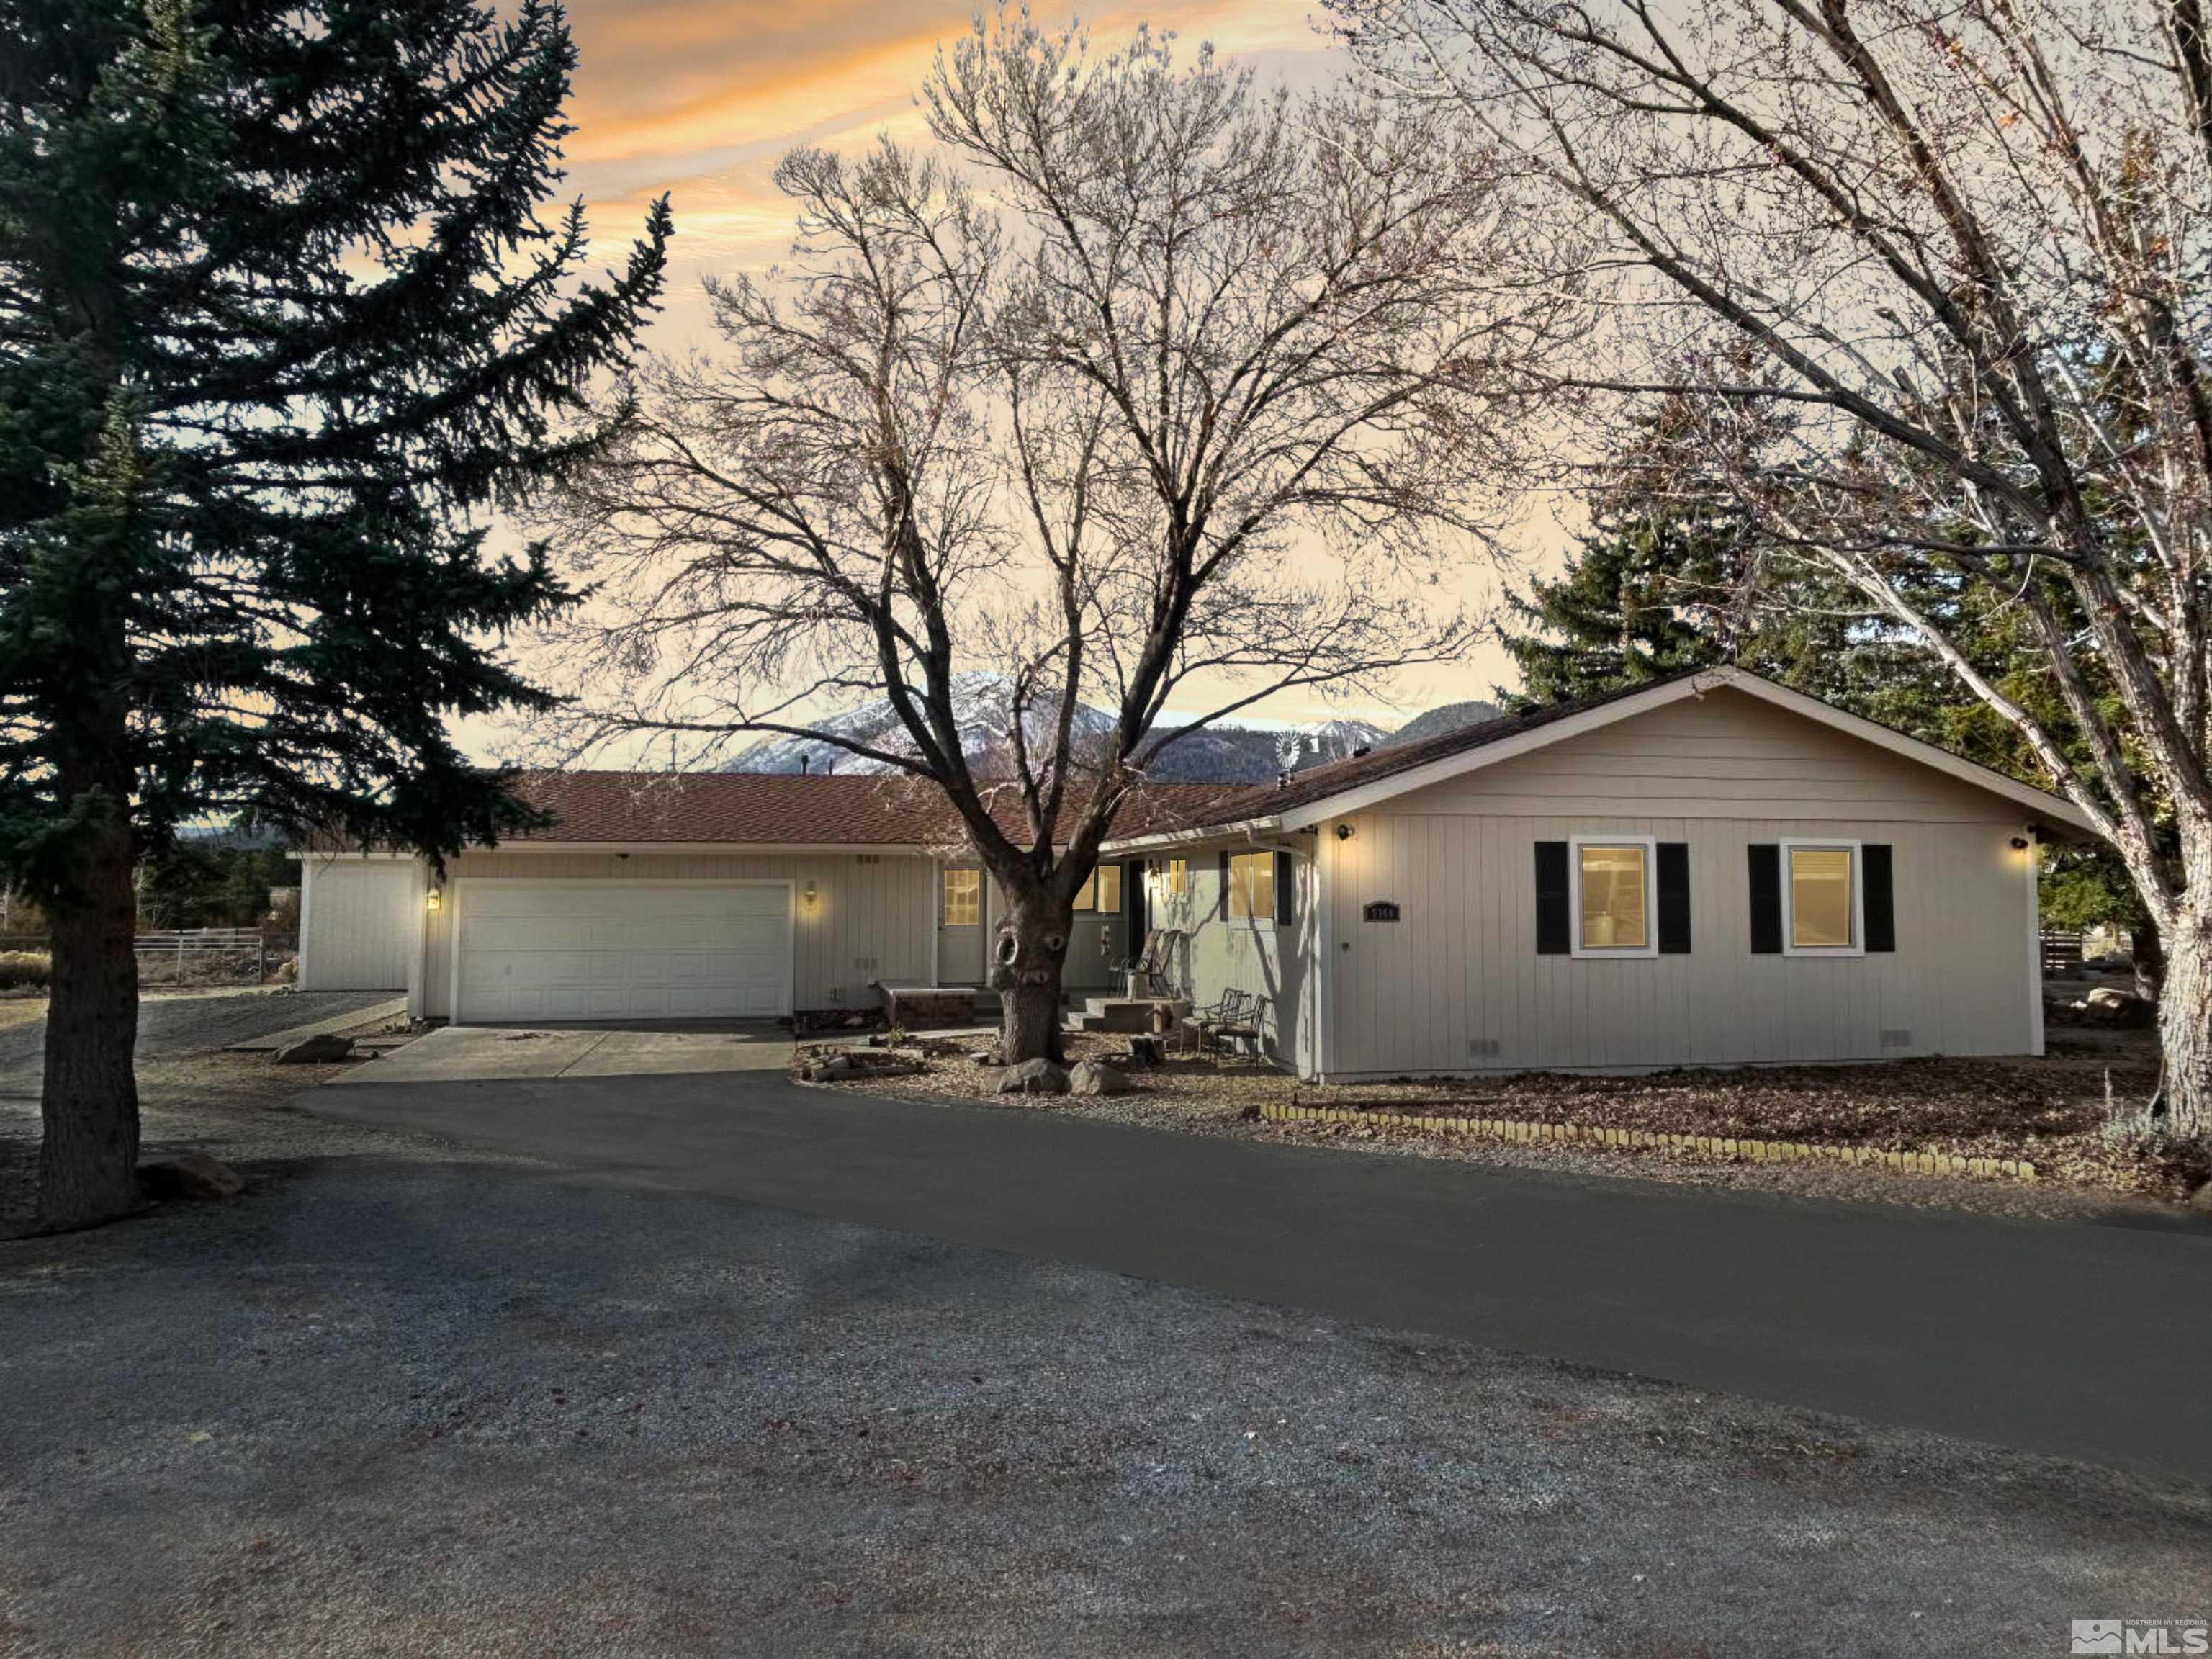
left=301, top=1073, right=2212, bottom=1480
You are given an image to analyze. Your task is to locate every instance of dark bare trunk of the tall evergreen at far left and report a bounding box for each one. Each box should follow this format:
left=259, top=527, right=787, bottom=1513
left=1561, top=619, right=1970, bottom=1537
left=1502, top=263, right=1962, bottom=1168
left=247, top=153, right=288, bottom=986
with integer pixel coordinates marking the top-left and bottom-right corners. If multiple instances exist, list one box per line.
left=37, top=786, right=140, bottom=1232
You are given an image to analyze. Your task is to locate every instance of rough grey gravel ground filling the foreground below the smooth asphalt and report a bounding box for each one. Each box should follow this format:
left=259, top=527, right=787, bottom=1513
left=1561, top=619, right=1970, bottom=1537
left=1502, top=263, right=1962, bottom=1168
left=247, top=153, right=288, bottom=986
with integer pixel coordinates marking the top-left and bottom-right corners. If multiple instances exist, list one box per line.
left=0, top=1055, right=2212, bottom=1659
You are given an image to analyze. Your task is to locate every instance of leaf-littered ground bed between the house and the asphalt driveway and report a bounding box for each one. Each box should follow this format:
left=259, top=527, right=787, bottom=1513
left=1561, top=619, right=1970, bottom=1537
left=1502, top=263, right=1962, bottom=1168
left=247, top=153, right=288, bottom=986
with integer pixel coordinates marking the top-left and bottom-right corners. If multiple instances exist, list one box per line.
left=801, top=1026, right=2212, bottom=1217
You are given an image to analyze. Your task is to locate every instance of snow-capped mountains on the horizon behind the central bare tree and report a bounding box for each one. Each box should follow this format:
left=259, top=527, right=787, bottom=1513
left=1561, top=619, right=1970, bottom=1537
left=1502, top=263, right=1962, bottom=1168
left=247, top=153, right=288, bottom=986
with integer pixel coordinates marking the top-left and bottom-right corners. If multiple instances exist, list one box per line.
left=728, top=673, right=1460, bottom=783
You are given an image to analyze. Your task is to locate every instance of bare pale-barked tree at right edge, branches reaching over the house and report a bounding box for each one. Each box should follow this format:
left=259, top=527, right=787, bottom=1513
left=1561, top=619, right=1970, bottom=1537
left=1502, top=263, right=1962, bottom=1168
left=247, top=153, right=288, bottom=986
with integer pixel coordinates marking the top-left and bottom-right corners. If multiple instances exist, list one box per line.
left=1339, top=0, right=2212, bottom=1137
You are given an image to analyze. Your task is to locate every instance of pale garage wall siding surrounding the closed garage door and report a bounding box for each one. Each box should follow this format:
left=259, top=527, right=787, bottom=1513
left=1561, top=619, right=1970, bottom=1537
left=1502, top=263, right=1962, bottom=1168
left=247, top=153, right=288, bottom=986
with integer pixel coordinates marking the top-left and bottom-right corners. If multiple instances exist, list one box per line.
left=421, top=850, right=938, bottom=1017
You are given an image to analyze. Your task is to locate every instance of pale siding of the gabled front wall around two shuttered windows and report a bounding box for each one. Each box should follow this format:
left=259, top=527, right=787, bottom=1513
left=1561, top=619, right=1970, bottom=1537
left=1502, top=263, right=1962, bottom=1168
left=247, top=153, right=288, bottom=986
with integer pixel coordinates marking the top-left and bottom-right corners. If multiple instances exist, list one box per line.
left=1318, top=690, right=2039, bottom=1077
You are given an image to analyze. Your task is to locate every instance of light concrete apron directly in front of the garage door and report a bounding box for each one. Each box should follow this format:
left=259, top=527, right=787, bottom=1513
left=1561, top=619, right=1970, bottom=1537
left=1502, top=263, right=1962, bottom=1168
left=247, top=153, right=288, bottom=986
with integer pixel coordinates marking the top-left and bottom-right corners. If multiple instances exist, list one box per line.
left=332, top=1024, right=792, bottom=1086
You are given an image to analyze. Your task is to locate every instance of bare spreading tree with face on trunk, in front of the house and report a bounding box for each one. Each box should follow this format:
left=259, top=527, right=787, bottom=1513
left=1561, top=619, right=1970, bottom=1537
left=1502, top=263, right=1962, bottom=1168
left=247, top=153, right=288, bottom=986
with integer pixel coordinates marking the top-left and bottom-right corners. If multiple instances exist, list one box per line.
left=555, top=13, right=1550, bottom=1059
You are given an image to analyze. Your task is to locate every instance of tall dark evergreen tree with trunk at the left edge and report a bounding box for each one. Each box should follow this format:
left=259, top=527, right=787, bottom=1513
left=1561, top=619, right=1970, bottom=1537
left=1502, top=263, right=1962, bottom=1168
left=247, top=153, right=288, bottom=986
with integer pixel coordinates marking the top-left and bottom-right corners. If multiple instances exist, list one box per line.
left=0, top=0, right=668, bottom=1228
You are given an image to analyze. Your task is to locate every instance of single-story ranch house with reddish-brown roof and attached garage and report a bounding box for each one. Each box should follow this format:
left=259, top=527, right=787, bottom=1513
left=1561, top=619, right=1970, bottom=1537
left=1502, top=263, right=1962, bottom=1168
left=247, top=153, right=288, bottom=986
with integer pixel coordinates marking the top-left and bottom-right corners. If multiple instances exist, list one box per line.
left=301, top=668, right=2090, bottom=1082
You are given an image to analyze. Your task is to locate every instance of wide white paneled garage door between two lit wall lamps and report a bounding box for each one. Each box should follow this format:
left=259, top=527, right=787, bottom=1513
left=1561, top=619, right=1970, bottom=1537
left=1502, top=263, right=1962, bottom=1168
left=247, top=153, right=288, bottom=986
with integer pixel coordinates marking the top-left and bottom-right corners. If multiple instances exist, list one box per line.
left=454, top=881, right=792, bottom=1024
